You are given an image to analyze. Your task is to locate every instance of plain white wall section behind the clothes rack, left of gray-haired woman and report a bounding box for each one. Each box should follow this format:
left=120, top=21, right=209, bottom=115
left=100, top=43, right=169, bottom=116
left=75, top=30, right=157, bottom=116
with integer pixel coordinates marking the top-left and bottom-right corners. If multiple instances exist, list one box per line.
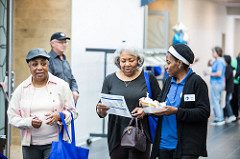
left=71, top=0, right=144, bottom=141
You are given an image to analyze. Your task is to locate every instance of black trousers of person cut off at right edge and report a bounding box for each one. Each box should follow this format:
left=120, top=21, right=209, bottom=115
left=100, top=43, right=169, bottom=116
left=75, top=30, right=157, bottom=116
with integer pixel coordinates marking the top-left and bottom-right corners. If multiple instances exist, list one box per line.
left=231, top=84, right=240, bottom=117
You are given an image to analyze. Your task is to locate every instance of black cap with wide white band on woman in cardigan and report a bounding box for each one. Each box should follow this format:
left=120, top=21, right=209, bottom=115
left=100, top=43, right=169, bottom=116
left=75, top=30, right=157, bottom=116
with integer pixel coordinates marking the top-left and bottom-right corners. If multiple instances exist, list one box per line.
left=168, top=44, right=194, bottom=65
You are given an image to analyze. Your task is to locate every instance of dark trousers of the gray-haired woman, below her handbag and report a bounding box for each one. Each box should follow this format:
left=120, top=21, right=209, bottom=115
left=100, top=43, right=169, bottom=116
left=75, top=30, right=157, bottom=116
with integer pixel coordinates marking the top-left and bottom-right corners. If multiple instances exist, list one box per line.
left=110, top=142, right=150, bottom=159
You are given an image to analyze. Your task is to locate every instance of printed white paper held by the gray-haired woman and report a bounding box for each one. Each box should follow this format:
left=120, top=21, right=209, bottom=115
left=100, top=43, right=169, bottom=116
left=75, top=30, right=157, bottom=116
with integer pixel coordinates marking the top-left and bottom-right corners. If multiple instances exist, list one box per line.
left=100, top=93, right=132, bottom=118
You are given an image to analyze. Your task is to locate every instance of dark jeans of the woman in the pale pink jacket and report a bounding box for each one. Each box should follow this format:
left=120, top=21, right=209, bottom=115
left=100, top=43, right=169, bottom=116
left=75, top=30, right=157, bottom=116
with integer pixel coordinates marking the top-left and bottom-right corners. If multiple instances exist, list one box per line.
left=22, top=144, right=52, bottom=159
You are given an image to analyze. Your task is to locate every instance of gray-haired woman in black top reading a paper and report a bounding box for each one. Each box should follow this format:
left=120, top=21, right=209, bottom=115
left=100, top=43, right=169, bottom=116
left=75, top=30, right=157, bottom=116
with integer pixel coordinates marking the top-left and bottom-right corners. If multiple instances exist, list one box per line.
left=96, top=48, right=161, bottom=159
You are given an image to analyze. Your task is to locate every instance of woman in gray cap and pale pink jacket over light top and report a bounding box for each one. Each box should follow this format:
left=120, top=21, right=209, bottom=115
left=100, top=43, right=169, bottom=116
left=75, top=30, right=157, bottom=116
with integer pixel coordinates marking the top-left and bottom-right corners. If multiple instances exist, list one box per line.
left=7, top=48, right=77, bottom=159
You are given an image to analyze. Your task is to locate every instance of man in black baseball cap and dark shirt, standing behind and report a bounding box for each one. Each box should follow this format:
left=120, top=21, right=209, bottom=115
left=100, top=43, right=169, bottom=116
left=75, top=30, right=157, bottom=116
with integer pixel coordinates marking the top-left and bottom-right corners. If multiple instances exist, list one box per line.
left=49, top=32, right=79, bottom=104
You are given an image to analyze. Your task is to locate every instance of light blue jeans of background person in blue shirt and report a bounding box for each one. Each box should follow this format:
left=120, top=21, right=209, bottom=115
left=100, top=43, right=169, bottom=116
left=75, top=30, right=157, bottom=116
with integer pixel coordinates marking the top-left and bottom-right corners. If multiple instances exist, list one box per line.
left=211, top=84, right=224, bottom=122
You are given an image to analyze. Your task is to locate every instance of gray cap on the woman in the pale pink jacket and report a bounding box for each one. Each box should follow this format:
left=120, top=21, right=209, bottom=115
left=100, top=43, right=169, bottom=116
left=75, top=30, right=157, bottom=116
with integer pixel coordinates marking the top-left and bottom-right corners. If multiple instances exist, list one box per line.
left=26, top=48, right=50, bottom=63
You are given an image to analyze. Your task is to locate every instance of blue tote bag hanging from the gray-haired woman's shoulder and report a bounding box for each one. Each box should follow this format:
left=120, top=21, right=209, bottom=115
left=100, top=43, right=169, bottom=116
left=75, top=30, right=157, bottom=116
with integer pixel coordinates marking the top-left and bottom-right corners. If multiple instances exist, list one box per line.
left=144, top=72, right=158, bottom=143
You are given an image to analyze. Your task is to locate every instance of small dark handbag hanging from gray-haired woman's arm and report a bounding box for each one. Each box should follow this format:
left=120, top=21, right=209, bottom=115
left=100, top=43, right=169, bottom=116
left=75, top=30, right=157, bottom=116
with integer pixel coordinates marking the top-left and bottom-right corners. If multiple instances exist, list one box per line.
left=121, top=118, right=147, bottom=152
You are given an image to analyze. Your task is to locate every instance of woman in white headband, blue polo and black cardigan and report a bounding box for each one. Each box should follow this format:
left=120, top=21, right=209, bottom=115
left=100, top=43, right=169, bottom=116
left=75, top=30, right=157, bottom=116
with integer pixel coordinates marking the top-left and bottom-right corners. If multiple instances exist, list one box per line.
left=137, top=44, right=210, bottom=159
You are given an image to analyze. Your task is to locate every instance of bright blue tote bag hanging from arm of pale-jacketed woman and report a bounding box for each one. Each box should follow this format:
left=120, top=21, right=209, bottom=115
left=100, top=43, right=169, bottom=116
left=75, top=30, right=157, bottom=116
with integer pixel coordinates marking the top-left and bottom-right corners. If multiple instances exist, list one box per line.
left=49, top=113, right=89, bottom=159
